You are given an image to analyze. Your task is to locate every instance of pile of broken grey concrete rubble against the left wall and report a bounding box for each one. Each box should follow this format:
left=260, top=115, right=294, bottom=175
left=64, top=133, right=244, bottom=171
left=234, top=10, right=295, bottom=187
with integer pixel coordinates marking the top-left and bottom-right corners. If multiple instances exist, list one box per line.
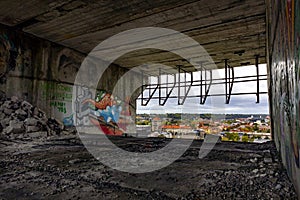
left=0, top=93, right=64, bottom=139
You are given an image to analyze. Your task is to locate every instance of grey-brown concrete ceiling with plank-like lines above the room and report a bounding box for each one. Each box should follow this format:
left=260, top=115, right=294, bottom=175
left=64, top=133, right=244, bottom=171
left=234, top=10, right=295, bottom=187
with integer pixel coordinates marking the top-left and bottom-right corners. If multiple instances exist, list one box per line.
left=0, top=0, right=266, bottom=73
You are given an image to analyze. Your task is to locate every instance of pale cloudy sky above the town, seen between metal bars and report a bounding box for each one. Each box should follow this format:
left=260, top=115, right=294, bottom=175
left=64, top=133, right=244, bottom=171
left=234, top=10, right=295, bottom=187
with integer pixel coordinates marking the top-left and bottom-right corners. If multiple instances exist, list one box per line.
left=137, top=64, right=269, bottom=114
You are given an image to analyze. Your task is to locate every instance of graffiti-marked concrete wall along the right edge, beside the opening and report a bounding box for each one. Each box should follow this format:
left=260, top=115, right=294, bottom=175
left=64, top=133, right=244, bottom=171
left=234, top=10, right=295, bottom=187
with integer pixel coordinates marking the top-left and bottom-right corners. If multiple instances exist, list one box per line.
left=267, top=0, right=300, bottom=195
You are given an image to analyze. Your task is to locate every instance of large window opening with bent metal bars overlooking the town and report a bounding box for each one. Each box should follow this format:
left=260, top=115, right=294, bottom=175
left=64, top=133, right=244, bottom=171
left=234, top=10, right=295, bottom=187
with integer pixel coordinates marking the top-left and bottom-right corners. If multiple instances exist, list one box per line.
left=136, top=64, right=271, bottom=142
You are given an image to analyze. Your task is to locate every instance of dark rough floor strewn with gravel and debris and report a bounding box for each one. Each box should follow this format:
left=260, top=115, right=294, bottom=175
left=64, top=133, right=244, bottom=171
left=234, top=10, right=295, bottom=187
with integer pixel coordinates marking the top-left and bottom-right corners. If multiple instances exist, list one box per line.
left=0, top=136, right=297, bottom=200
